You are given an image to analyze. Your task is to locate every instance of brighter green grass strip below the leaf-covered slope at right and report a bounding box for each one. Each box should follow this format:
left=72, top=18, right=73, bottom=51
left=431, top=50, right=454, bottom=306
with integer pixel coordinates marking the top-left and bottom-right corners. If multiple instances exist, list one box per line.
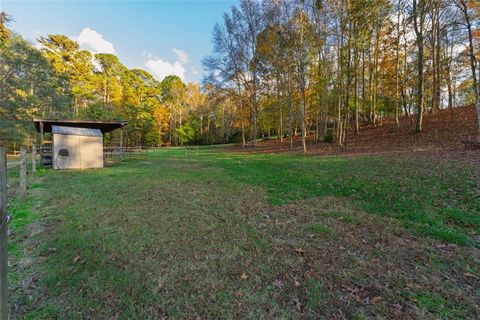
left=206, top=155, right=480, bottom=245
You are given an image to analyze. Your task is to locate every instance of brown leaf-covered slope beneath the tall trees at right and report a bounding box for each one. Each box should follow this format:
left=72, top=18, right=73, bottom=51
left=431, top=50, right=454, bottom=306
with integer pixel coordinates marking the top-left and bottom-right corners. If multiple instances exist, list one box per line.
left=230, top=107, right=479, bottom=161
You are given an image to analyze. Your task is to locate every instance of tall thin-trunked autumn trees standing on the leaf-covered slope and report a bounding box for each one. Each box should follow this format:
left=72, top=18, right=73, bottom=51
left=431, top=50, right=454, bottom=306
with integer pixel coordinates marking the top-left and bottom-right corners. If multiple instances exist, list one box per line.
left=203, top=0, right=480, bottom=152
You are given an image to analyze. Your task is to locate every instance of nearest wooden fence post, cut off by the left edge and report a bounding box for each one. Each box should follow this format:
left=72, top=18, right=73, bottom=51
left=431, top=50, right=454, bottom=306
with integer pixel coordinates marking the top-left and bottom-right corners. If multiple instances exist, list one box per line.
left=0, top=147, right=8, bottom=320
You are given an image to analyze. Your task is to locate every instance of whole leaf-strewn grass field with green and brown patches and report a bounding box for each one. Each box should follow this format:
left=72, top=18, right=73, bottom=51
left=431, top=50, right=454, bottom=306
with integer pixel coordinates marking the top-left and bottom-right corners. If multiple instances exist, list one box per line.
left=10, top=148, right=480, bottom=319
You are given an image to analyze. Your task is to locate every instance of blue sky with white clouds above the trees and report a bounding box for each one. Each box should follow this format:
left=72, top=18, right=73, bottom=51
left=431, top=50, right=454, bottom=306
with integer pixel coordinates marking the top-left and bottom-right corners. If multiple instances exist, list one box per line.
left=0, top=0, right=236, bottom=82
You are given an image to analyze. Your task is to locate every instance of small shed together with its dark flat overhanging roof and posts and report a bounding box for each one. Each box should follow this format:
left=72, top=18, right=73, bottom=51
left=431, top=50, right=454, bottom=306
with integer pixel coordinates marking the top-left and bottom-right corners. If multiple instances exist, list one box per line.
left=33, top=119, right=128, bottom=169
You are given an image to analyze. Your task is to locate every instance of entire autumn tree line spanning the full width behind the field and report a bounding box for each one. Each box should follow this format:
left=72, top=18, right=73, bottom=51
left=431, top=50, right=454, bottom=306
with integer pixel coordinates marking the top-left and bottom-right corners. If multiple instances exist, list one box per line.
left=0, top=0, right=480, bottom=152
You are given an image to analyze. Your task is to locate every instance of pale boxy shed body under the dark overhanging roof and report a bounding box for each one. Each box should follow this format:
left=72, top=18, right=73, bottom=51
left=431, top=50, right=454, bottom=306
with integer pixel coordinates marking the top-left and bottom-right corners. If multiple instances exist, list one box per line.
left=52, top=125, right=103, bottom=169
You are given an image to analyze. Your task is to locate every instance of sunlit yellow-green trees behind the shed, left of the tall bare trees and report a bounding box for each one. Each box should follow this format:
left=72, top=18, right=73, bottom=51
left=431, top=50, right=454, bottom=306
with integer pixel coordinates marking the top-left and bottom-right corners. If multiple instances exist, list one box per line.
left=0, top=12, right=231, bottom=149
